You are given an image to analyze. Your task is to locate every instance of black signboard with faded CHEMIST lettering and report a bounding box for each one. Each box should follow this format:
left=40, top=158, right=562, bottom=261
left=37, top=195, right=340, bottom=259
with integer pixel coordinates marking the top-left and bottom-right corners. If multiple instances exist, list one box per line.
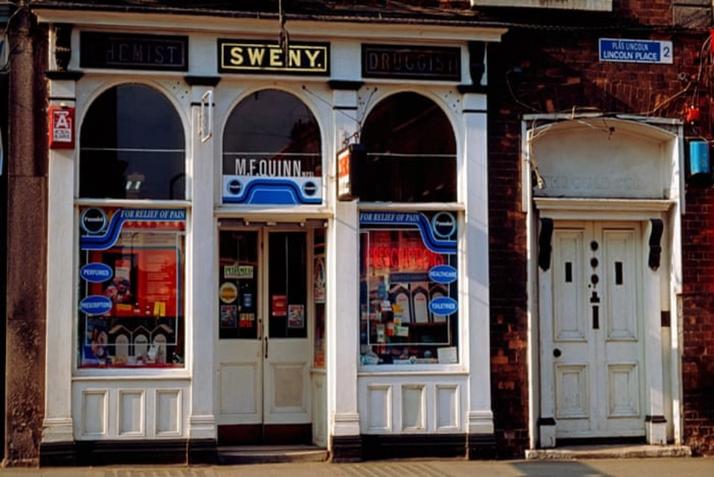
left=79, top=31, right=188, bottom=71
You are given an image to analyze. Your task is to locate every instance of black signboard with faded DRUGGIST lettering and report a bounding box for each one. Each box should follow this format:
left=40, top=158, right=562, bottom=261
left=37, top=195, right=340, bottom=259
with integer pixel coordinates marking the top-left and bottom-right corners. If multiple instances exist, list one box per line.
left=362, top=44, right=461, bottom=81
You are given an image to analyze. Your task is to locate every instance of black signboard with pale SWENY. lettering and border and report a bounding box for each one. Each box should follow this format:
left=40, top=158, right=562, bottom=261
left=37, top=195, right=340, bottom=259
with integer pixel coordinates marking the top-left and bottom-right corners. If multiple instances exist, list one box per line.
left=218, top=39, right=330, bottom=76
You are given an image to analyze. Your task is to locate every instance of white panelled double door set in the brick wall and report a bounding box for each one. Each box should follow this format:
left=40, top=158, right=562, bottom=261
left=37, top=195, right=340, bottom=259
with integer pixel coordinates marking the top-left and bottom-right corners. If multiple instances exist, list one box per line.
left=539, top=222, right=645, bottom=439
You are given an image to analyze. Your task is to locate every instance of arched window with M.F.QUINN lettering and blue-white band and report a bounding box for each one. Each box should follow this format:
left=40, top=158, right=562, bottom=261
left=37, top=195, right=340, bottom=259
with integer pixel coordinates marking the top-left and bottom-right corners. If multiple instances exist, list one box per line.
left=222, top=89, right=322, bottom=205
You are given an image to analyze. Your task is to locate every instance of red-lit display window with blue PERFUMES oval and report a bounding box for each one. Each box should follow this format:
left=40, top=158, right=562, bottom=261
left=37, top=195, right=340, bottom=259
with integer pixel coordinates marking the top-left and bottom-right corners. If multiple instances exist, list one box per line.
left=78, top=207, right=186, bottom=368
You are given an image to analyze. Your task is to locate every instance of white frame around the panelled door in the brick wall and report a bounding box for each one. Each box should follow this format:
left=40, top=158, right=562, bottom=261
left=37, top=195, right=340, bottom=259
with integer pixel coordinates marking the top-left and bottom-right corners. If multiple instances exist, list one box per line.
left=527, top=198, right=681, bottom=449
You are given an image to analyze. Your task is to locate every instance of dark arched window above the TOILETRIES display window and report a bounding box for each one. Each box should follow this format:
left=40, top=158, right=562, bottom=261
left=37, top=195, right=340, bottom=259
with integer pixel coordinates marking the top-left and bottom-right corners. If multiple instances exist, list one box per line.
left=360, top=93, right=456, bottom=202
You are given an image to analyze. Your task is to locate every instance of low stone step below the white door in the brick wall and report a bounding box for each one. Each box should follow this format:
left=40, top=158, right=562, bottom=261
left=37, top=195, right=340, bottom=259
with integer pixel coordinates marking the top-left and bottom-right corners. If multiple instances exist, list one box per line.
left=526, top=444, right=692, bottom=460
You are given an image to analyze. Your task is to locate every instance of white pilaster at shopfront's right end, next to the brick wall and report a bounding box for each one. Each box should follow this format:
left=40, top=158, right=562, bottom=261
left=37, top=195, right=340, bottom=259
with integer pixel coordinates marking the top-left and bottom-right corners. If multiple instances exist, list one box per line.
left=460, top=94, right=494, bottom=434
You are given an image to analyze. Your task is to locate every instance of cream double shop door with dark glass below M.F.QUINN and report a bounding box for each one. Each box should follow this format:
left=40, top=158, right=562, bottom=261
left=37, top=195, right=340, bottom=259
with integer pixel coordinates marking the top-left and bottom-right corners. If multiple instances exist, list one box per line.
left=218, top=227, right=311, bottom=444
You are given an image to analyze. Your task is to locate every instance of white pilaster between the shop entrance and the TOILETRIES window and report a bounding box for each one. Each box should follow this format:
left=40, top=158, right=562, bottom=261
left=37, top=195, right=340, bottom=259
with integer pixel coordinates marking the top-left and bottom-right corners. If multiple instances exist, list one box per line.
left=327, top=90, right=360, bottom=440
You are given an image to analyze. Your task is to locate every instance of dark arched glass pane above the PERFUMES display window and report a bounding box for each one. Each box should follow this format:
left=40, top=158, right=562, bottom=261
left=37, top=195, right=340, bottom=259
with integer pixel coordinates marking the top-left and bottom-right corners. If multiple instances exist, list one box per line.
left=79, top=85, right=186, bottom=199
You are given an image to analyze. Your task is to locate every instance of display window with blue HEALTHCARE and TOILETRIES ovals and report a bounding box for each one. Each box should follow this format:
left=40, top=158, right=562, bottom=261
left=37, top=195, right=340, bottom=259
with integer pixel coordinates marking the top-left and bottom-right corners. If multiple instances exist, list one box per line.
left=360, top=212, right=459, bottom=365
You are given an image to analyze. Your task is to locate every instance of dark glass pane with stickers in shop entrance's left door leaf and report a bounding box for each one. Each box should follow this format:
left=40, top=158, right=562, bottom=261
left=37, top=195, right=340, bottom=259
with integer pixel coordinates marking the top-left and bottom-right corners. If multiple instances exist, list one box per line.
left=218, top=230, right=259, bottom=339
